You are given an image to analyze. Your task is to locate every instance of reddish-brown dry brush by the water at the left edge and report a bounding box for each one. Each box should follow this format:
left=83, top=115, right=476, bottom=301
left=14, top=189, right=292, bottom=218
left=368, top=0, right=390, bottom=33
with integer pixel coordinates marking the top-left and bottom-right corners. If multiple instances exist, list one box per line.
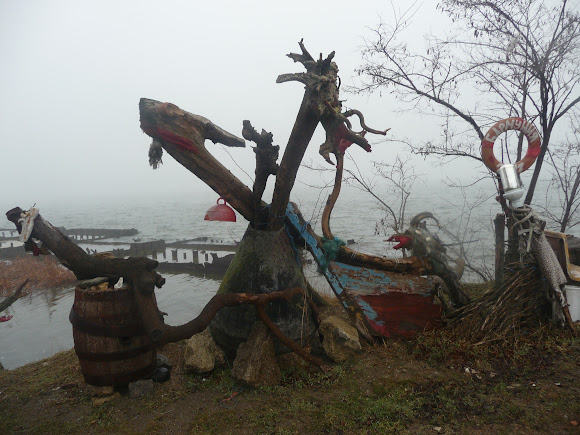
left=0, top=255, right=77, bottom=296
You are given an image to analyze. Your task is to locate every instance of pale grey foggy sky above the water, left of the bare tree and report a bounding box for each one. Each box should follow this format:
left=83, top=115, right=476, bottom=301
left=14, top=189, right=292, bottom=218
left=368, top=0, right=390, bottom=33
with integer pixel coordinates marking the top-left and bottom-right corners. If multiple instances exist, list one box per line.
left=0, top=0, right=488, bottom=211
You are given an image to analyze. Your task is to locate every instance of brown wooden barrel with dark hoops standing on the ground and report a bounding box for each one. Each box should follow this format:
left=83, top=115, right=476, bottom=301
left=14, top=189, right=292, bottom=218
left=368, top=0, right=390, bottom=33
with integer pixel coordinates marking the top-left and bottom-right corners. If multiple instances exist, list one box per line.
left=69, top=287, right=157, bottom=386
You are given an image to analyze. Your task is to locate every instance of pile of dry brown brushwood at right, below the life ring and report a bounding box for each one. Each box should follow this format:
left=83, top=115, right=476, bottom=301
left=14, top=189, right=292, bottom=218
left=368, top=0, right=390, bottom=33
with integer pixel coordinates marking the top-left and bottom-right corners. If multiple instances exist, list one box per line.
left=447, top=263, right=550, bottom=343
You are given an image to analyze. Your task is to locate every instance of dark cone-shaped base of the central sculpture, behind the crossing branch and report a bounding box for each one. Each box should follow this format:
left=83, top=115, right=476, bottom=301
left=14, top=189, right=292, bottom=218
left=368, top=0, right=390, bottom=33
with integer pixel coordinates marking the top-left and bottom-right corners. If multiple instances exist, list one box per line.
left=210, top=227, right=316, bottom=356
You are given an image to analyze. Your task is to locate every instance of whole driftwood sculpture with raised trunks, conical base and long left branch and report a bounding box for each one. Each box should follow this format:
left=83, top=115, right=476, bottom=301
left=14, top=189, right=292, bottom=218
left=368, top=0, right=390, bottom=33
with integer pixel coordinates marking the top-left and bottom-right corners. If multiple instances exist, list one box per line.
left=7, top=41, right=454, bottom=366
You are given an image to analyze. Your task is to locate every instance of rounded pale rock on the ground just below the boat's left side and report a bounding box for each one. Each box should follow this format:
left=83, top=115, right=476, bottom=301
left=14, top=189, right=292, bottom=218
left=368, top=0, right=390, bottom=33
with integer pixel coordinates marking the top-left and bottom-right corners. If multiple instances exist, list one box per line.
left=318, top=316, right=361, bottom=362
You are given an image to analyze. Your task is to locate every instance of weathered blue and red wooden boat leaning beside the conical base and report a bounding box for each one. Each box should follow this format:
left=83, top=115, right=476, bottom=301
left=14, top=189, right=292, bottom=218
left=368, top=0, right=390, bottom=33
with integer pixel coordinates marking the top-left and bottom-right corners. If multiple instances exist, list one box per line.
left=285, top=151, right=442, bottom=337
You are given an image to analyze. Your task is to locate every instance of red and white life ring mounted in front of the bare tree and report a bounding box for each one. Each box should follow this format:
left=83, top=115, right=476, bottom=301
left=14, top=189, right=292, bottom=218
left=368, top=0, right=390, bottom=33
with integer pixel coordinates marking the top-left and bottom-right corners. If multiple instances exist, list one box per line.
left=481, top=118, right=542, bottom=174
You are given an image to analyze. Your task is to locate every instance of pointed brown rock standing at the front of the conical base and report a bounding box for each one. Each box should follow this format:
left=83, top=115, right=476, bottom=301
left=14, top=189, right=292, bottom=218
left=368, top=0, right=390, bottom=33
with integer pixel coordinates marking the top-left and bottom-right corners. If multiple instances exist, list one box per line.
left=232, top=321, right=282, bottom=387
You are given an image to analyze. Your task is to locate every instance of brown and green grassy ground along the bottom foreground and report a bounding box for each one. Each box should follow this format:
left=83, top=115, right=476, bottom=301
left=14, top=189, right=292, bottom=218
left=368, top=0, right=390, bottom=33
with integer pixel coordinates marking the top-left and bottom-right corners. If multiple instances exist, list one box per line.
left=0, top=327, right=580, bottom=434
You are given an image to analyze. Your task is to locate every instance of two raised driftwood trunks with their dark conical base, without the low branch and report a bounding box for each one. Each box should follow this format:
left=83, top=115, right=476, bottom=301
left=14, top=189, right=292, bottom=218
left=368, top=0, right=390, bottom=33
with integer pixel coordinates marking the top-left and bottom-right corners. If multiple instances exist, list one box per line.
left=139, top=42, right=386, bottom=355
